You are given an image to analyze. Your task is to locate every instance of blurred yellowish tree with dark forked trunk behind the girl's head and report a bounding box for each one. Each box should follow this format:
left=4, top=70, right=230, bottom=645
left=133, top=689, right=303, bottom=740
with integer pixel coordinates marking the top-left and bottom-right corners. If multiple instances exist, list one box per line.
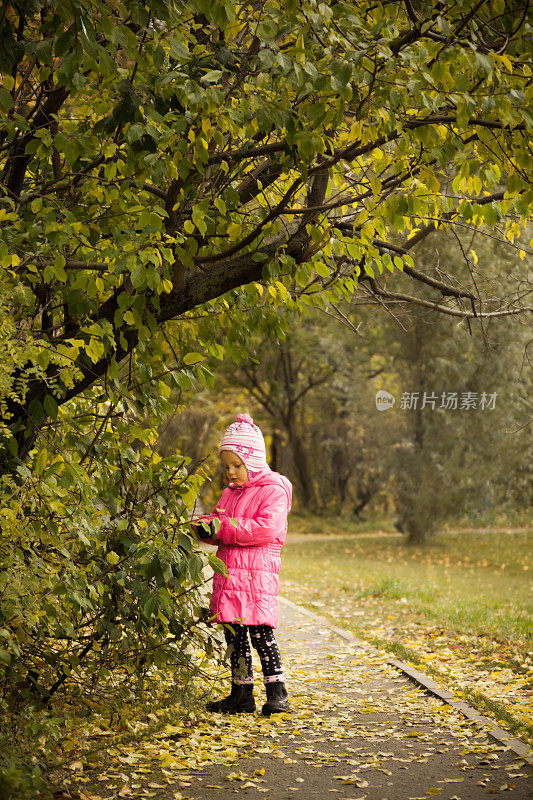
left=214, top=312, right=379, bottom=512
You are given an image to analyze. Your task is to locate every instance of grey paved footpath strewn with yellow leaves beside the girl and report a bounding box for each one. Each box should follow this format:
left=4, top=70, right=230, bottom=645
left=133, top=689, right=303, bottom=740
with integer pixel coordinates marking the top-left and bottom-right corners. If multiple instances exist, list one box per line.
left=165, top=605, right=533, bottom=800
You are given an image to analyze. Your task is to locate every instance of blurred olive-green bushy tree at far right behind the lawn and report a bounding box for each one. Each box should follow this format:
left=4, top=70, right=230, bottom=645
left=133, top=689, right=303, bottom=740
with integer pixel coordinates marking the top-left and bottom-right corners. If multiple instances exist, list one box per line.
left=385, top=234, right=533, bottom=544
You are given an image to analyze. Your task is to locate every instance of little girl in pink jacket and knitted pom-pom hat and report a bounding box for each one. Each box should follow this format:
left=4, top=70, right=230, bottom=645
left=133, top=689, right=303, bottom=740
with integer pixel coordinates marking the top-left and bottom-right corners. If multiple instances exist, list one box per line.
left=195, top=414, right=292, bottom=716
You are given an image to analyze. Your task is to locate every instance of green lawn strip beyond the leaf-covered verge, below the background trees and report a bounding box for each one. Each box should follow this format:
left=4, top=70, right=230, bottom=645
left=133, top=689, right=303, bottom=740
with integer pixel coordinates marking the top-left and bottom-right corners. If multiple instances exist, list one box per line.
left=283, top=519, right=533, bottom=643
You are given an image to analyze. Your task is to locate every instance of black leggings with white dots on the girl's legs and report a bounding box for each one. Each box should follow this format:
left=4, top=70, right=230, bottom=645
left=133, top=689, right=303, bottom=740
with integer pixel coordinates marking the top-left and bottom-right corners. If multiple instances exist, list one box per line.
left=224, top=624, right=285, bottom=683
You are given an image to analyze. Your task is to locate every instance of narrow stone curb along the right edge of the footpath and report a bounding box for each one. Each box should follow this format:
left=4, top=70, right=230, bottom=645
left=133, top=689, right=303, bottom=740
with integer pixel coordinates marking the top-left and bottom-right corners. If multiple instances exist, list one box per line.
left=279, top=595, right=533, bottom=766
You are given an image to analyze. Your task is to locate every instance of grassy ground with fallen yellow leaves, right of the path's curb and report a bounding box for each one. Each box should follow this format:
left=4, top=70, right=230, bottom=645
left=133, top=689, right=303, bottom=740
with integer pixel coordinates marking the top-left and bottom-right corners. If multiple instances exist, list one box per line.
left=281, top=518, right=533, bottom=741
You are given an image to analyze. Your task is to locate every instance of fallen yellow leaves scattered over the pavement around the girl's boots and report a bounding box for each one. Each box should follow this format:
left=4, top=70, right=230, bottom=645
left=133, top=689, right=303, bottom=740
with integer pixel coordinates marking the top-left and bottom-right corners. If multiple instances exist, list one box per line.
left=56, top=612, right=526, bottom=800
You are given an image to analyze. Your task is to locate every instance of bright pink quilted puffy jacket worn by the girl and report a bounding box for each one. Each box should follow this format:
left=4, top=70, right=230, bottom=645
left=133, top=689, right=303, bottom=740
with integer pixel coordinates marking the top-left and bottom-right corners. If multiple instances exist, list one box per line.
left=204, top=469, right=292, bottom=628
